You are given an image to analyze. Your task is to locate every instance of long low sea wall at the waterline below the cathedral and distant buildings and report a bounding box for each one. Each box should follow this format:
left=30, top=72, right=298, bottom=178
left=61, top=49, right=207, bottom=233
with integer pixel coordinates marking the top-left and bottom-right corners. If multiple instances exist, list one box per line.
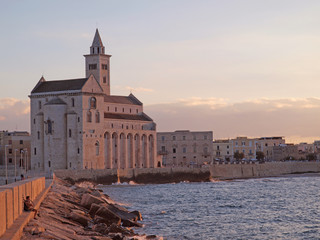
left=55, top=161, right=320, bottom=184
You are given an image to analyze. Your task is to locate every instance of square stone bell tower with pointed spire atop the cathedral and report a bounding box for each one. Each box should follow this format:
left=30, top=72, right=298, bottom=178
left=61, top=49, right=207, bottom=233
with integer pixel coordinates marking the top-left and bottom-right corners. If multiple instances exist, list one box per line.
left=84, top=29, right=111, bottom=95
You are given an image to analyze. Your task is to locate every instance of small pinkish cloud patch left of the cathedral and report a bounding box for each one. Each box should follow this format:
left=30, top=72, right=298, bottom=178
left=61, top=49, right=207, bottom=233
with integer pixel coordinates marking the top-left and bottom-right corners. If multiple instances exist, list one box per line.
left=0, top=98, right=30, bottom=131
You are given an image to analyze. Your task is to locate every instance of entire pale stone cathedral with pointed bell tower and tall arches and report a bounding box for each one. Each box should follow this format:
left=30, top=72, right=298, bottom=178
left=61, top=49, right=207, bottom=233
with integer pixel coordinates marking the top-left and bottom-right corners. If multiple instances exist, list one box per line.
left=29, top=29, right=160, bottom=172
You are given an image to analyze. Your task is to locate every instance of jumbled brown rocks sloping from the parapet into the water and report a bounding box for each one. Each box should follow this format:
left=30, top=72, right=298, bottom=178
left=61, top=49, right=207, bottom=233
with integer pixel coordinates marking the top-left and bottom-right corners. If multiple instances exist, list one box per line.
left=21, top=178, right=162, bottom=240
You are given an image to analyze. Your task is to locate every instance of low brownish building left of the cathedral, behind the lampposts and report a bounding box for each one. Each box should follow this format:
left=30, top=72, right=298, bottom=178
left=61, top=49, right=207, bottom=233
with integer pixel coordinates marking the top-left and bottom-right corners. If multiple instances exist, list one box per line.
left=0, top=131, right=31, bottom=169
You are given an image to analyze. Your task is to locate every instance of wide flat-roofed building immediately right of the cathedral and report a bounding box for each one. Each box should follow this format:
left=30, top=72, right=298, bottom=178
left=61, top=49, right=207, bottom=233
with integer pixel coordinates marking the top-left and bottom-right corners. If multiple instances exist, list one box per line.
left=157, top=130, right=213, bottom=166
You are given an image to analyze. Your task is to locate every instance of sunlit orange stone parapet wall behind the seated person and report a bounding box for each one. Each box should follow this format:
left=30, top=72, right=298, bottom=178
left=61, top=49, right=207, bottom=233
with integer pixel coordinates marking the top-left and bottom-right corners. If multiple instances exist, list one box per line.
left=0, top=177, right=45, bottom=237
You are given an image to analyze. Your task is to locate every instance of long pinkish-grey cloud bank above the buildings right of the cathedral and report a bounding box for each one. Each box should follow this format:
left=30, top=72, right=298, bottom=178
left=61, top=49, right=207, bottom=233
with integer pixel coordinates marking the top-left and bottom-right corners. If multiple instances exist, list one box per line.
left=145, top=98, right=320, bottom=142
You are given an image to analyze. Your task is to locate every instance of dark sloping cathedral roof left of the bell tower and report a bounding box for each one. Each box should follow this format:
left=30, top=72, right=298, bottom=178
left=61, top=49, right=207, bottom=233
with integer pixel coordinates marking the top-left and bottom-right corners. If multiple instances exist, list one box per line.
left=31, top=78, right=88, bottom=93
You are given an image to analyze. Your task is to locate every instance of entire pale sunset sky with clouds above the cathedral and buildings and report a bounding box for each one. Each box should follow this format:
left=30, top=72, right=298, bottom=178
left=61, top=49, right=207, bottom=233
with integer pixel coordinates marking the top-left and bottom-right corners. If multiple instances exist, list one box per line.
left=0, top=0, right=320, bottom=143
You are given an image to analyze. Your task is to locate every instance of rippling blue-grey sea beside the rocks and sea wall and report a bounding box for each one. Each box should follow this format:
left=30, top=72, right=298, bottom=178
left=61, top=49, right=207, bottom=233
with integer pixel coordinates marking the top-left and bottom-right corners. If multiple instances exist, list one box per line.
left=100, top=174, right=320, bottom=240
